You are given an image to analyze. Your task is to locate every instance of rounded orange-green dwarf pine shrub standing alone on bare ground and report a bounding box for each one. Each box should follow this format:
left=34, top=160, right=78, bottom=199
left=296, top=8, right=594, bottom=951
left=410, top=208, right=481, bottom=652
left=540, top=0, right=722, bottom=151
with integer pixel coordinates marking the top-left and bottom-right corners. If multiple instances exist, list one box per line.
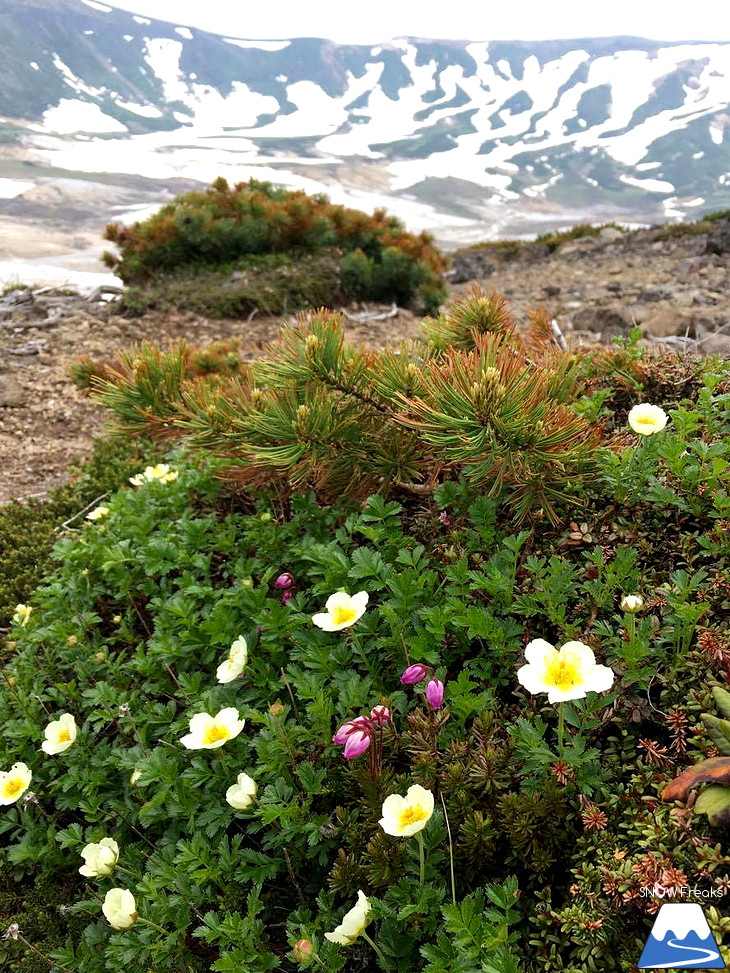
left=104, top=178, right=445, bottom=316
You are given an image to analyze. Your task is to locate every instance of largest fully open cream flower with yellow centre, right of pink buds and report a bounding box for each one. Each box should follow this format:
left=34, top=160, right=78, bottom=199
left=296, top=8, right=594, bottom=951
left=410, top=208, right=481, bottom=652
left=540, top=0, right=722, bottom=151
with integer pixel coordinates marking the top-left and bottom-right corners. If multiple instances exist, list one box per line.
left=517, top=639, right=614, bottom=703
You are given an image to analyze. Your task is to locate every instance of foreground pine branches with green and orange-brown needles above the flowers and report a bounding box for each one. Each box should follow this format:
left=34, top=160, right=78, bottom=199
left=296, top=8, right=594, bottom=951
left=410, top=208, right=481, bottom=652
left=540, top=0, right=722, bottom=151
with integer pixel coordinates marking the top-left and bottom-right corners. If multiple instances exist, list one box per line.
left=86, top=290, right=600, bottom=522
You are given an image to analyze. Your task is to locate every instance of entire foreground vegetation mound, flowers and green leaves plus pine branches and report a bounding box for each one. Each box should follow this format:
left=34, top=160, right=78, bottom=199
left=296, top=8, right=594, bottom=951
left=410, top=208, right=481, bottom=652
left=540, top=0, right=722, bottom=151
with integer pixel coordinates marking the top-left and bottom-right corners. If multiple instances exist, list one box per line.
left=0, top=291, right=730, bottom=973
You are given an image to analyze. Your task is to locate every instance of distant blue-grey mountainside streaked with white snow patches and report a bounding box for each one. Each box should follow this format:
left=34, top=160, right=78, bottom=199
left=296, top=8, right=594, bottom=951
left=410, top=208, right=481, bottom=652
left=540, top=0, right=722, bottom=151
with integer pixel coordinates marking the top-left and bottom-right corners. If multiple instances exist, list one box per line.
left=0, top=0, right=730, bottom=244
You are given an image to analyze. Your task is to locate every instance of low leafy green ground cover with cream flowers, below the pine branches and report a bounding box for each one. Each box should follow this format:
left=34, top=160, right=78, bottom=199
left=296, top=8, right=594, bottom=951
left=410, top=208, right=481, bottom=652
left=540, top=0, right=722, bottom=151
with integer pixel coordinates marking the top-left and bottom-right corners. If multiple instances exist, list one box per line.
left=0, top=348, right=730, bottom=973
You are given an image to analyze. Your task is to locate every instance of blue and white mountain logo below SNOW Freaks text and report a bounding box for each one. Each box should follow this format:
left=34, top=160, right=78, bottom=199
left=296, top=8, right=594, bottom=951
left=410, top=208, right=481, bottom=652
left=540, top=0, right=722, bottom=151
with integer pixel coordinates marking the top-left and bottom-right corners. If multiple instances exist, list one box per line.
left=639, top=902, right=726, bottom=970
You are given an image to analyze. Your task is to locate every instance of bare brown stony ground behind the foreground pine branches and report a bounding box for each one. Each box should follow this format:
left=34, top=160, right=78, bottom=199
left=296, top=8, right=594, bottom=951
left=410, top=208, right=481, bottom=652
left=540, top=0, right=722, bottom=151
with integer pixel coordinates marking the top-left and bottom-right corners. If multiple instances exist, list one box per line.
left=0, top=221, right=730, bottom=501
